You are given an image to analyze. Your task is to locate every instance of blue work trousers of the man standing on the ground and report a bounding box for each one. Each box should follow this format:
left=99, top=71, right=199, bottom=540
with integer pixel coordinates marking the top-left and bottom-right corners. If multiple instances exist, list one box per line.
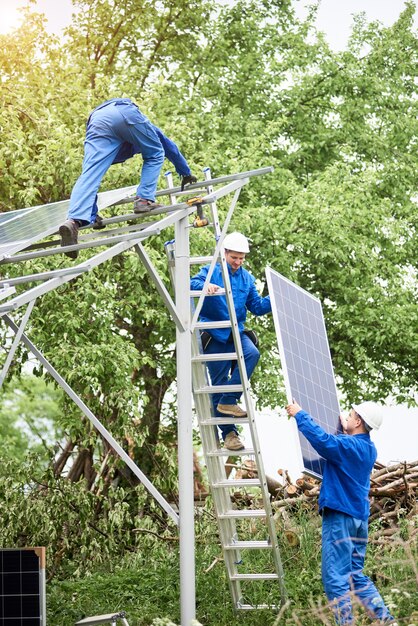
left=322, top=509, right=393, bottom=625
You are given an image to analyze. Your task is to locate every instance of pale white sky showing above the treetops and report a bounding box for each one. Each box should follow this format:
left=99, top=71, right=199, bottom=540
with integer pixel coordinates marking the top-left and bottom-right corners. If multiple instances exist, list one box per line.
left=0, top=0, right=416, bottom=50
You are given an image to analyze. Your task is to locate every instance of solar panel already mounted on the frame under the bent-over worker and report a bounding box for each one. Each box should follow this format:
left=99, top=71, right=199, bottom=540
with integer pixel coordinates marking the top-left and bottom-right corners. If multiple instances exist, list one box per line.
left=0, top=187, right=136, bottom=261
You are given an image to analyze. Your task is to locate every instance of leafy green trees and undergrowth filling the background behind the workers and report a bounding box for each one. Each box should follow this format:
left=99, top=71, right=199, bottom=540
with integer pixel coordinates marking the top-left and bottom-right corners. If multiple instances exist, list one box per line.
left=0, top=0, right=418, bottom=626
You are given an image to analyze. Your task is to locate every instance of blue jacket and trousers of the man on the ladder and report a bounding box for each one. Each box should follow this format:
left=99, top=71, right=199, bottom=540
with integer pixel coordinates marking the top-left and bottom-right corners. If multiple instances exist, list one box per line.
left=190, top=264, right=271, bottom=439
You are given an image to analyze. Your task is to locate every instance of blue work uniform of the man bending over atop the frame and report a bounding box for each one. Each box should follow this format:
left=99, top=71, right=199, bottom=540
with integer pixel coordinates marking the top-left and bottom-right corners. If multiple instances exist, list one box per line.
left=68, top=98, right=191, bottom=224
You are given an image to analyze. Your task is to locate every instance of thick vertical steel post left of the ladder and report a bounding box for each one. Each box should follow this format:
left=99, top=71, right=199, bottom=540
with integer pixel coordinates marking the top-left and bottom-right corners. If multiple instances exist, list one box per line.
left=166, top=173, right=196, bottom=626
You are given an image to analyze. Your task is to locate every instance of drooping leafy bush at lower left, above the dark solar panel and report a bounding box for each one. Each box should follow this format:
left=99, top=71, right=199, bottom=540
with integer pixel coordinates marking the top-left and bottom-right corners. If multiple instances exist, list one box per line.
left=0, top=448, right=178, bottom=579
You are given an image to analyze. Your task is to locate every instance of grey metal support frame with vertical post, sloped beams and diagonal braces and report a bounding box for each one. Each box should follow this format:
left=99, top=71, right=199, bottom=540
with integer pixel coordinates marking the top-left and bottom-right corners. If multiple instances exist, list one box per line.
left=0, top=167, right=273, bottom=626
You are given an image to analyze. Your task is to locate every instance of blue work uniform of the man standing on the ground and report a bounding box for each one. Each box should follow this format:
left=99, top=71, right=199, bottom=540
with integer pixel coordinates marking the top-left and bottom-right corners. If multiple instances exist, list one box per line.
left=295, top=411, right=393, bottom=624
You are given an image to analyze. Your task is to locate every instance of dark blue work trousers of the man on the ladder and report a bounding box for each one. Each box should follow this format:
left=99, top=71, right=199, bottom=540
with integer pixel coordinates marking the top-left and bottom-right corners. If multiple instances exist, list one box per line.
left=205, top=333, right=260, bottom=439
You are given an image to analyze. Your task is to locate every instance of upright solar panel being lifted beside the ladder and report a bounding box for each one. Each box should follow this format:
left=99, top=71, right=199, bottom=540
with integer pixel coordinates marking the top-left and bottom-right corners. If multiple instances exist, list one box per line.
left=266, top=268, right=340, bottom=477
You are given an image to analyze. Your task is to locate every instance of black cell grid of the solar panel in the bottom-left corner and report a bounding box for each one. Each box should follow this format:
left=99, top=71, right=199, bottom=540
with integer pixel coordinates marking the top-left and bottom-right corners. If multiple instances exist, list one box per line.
left=0, top=549, right=43, bottom=626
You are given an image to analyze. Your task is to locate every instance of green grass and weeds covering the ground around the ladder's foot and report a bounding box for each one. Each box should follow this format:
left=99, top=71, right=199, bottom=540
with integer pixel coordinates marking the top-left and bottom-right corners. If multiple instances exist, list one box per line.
left=47, top=510, right=418, bottom=626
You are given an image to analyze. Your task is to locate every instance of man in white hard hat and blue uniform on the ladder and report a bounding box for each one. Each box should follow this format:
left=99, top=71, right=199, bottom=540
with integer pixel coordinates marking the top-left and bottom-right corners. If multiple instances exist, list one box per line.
left=191, top=232, right=271, bottom=450
